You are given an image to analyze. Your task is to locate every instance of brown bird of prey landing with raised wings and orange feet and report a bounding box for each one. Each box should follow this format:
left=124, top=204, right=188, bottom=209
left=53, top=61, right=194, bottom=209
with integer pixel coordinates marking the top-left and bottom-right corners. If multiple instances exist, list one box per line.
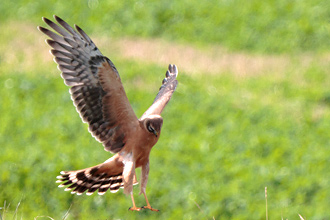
left=38, top=16, right=178, bottom=211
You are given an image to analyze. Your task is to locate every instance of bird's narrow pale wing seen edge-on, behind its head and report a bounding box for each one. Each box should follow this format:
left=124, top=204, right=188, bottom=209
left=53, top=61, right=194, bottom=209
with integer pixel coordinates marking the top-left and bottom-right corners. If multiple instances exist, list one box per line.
left=141, top=64, right=178, bottom=119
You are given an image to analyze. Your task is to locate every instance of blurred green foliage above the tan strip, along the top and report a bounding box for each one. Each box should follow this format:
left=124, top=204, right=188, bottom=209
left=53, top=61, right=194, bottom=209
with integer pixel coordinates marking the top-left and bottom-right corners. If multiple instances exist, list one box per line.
left=0, top=0, right=330, bottom=53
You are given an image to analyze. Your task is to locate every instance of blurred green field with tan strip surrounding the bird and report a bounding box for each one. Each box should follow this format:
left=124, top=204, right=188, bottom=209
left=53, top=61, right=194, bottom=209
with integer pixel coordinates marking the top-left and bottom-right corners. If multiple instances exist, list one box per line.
left=0, top=0, right=330, bottom=219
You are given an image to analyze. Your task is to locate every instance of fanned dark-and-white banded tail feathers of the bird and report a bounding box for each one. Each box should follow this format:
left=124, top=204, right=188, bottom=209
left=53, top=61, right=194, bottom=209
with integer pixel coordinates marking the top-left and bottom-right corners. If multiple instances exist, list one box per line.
left=56, top=164, right=124, bottom=195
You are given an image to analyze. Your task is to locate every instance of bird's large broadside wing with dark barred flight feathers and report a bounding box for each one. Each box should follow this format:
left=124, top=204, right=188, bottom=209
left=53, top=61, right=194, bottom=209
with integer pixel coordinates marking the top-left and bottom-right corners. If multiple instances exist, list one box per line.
left=38, top=16, right=137, bottom=153
